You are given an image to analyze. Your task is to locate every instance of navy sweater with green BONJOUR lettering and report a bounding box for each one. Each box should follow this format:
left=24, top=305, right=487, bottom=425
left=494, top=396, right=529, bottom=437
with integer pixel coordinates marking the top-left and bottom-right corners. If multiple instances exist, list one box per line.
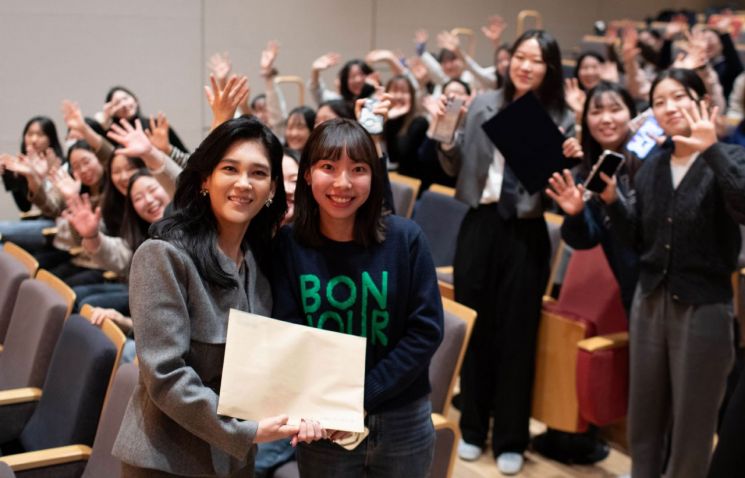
left=272, top=216, right=443, bottom=413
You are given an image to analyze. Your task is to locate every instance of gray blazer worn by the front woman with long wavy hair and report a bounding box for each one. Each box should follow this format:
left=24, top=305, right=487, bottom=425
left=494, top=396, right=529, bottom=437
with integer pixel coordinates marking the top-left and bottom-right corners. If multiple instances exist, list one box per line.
left=112, top=239, right=272, bottom=476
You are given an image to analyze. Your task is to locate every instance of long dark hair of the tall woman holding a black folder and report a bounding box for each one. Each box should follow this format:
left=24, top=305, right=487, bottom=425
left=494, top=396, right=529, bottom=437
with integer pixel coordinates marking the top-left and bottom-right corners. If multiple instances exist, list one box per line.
left=504, top=30, right=567, bottom=116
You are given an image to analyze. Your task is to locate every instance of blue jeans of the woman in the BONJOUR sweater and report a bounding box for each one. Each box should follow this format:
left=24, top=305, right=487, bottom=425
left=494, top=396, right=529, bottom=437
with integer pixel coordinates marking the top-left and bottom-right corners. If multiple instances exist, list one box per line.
left=297, top=397, right=435, bottom=478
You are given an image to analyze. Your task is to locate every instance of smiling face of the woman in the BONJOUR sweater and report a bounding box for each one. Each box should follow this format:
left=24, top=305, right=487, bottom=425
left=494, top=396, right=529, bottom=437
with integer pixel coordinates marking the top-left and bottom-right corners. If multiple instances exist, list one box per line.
left=304, top=151, right=372, bottom=241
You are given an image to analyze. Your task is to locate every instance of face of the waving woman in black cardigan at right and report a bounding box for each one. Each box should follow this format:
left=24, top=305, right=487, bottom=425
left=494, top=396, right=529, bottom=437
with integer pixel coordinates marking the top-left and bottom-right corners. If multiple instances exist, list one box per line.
left=652, top=78, right=696, bottom=136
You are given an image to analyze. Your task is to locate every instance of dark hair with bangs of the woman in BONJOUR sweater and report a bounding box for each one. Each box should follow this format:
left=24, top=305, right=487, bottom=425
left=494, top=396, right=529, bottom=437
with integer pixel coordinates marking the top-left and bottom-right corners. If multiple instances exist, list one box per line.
left=293, top=118, right=386, bottom=247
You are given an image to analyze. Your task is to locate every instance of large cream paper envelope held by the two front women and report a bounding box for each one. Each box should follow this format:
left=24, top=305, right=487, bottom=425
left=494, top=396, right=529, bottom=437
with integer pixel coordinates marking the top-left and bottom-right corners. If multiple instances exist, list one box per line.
left=217, top=309, right=366, bottom=432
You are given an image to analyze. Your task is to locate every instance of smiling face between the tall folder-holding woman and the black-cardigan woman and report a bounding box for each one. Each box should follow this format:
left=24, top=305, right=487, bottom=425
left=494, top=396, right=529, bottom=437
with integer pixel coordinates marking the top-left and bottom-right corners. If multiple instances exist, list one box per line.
left=587, top=92, right=631, bottom=151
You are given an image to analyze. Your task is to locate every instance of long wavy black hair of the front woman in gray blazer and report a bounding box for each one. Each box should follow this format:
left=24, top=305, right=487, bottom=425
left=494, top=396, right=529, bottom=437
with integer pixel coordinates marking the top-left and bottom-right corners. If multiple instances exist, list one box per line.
left=150, top=115, right=287, bottom=289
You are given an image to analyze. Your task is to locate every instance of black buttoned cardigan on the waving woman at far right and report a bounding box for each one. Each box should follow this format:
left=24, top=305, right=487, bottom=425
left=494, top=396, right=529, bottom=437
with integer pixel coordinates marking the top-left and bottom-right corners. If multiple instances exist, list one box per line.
left=607, top=143, right=745, bottom=304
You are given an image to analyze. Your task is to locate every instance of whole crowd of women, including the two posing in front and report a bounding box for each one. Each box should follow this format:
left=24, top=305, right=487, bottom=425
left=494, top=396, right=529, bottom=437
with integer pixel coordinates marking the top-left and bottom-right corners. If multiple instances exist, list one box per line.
left=0, top=7, right=745, bottom=478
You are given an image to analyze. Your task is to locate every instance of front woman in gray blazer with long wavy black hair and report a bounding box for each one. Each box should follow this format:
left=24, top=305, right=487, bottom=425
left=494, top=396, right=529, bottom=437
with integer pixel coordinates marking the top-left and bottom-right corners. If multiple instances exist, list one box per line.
left=112, top=117, right=325, bottom=477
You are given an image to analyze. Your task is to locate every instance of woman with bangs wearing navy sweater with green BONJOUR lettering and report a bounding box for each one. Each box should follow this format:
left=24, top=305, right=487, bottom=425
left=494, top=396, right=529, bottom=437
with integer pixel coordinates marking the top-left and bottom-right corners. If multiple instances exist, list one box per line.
left=272, top=119, right=443, bottom=478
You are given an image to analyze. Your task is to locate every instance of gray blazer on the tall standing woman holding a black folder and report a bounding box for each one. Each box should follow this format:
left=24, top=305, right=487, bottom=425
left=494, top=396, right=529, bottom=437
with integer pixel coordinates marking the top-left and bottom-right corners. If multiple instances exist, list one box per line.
left=437, top=90, right=574, bottom=217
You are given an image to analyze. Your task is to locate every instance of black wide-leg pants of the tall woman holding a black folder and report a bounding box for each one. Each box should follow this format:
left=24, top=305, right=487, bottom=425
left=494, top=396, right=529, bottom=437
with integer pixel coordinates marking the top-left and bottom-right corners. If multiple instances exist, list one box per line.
left=454, top=204, right=550, bottom=456
